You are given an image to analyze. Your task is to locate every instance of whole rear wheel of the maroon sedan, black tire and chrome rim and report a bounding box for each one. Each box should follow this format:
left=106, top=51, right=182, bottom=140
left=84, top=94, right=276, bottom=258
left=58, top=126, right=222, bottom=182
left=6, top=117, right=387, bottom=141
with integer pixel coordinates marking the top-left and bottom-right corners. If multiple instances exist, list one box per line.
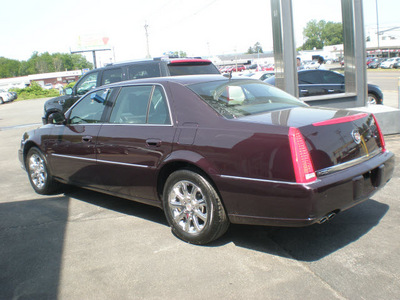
left=163, top=170, right=229, bottom=245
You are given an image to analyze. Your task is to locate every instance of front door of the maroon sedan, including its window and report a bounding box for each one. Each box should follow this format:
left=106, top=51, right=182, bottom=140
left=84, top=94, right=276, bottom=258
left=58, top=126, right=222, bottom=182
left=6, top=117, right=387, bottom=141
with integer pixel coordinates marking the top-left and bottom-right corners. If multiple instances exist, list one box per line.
left=48, top=89, right=111, bottom=185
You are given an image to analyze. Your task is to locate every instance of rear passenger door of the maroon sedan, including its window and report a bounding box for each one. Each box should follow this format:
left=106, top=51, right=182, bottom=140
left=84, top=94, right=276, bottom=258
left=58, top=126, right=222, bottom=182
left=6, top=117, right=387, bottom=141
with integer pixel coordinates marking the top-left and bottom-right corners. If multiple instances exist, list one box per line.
left=96, top=85, right=175, bottom=202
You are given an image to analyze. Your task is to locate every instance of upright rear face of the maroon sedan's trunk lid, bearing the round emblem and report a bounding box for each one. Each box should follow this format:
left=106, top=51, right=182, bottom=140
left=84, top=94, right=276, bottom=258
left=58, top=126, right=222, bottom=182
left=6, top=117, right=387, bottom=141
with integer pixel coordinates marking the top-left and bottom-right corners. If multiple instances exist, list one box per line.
left=299, top=110, right=384, bottom=175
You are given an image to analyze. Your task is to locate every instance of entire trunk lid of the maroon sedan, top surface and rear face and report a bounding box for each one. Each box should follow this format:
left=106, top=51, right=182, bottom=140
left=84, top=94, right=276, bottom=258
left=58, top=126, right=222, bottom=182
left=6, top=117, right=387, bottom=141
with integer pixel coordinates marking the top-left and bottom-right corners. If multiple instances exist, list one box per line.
left=240, top=107, right=384, bottom=176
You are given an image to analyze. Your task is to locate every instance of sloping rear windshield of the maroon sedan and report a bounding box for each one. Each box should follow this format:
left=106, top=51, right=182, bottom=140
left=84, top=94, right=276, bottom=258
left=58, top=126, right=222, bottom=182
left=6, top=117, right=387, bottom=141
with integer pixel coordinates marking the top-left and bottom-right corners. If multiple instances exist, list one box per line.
left=188, top=80, right=308, bottom=119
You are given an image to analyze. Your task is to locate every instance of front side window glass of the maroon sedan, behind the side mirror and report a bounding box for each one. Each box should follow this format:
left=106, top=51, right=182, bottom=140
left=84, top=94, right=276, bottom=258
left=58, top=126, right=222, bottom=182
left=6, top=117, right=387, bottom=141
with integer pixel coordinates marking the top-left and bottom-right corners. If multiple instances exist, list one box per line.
left=68, top=89, right=111, bottom=124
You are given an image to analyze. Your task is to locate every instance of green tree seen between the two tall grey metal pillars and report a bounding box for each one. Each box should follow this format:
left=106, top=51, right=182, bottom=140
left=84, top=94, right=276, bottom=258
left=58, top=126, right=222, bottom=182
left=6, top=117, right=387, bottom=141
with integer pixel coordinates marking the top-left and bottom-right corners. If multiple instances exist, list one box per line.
left=299, top=20, right=343, bottom=50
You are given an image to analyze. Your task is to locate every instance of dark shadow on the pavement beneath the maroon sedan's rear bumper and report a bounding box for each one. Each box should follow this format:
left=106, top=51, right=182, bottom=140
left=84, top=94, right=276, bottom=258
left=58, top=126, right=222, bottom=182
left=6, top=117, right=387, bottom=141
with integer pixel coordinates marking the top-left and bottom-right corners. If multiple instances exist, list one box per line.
left=219, top=200, right=389, bottom=262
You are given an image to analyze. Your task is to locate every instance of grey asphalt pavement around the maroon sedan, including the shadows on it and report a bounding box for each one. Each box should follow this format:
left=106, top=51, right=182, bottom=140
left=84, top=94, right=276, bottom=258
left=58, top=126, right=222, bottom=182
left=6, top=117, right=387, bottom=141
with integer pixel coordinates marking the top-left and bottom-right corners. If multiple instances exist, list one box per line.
left=0, top=99, right=400, bottom=299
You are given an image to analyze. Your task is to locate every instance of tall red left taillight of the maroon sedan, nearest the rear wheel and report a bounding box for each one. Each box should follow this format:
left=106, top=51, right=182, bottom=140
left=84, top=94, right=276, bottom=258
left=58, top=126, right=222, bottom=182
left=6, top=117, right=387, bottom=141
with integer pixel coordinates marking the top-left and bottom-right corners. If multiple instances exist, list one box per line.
left=289, top=127, right=317, bottom=183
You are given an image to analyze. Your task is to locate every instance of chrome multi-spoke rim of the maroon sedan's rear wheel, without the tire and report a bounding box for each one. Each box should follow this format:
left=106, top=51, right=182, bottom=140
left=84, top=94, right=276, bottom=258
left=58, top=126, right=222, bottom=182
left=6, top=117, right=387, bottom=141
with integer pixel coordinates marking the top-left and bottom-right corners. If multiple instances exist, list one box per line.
left=168, top=180, right=209, bottom=234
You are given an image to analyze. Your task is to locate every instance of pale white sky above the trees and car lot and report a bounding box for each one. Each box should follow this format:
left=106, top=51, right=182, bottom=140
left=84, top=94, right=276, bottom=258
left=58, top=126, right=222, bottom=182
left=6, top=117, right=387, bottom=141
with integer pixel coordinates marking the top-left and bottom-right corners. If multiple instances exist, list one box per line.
left=0, top=0, right=400, bottom=63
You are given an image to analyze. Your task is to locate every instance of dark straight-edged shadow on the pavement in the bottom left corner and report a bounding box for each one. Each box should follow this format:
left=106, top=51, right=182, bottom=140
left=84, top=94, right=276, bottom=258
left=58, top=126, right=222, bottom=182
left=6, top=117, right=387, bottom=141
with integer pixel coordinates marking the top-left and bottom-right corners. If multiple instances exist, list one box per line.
left=0, top=196, right=69, bottom=299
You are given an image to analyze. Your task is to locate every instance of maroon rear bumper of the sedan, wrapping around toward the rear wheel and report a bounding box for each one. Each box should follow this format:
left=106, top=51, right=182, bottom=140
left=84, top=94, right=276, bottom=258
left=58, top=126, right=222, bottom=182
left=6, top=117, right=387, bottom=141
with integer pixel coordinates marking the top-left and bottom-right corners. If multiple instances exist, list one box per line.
left=215, top=151, right=395, bottom=227
